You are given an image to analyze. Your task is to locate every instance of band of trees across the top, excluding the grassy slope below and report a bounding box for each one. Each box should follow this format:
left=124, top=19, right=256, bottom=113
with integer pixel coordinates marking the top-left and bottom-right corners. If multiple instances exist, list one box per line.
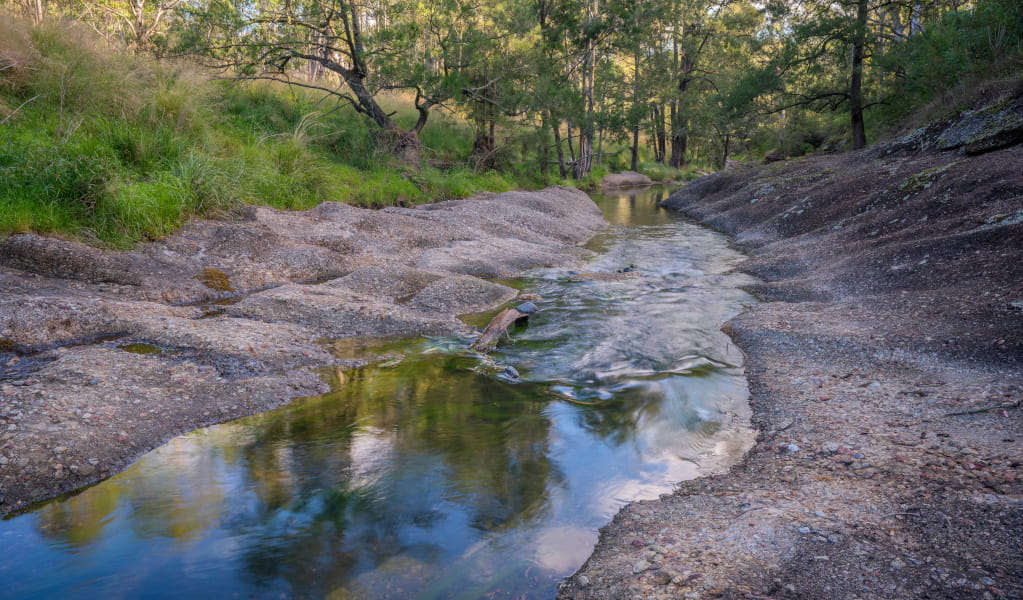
left=0, top=0, right=1023, bottom=173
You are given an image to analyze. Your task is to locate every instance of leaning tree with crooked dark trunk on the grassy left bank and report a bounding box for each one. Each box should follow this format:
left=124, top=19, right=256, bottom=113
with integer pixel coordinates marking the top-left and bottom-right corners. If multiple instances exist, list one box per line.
left=180, top=0, right=479, bottom=158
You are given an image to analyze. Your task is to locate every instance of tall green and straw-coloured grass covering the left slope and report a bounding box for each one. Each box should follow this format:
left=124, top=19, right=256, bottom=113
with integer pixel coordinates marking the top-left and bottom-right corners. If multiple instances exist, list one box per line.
left=0, top=15, right=513, bottom=247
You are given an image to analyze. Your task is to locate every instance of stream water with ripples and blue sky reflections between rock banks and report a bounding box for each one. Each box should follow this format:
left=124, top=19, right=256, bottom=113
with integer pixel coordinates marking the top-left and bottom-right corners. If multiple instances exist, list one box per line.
left=0, top=187, right=752, bottom=599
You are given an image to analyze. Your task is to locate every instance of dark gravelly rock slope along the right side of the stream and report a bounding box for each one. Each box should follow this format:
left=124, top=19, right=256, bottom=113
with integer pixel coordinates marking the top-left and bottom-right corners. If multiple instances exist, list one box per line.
left=560, top=97, right=1023, bottom=599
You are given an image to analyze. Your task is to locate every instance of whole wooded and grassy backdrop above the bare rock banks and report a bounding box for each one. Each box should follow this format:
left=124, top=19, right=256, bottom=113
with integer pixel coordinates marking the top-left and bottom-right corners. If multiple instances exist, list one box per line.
left=0, top=0, right=1023, bottom=247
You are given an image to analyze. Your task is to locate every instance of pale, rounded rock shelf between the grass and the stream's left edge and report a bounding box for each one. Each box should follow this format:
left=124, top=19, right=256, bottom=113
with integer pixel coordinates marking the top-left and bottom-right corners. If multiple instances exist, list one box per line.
left=0, top=187, right=606, bottom=514
